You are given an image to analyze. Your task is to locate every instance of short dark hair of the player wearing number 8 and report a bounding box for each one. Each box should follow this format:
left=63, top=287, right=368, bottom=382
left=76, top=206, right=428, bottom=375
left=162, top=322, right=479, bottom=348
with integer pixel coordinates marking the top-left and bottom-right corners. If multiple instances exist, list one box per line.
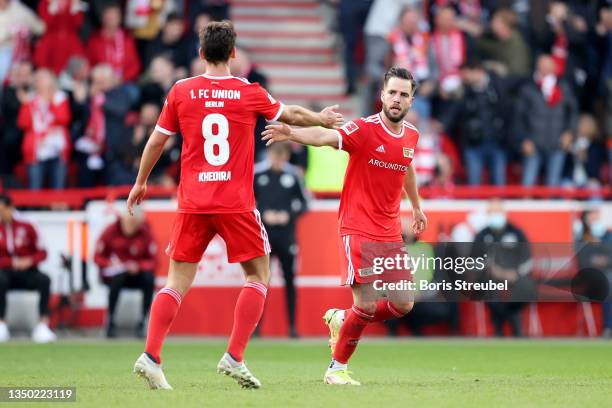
left=200, top=20, right=236, bottom=64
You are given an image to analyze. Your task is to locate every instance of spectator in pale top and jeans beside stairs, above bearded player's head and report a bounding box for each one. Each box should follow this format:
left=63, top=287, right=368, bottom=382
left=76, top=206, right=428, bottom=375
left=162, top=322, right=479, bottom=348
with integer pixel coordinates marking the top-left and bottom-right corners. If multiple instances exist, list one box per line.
left=363, top=0, right=421, bottom=116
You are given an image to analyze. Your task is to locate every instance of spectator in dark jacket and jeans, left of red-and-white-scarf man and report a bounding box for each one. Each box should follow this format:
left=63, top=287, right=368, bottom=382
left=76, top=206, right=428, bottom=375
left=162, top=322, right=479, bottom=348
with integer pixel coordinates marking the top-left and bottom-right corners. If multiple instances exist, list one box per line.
left=452, top=62, right=510, bottom=186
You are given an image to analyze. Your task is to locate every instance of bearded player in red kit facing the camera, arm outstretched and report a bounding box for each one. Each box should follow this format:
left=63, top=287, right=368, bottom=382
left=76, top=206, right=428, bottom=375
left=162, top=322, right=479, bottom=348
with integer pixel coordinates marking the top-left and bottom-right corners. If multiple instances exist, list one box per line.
left=263, top=67, right=427, bottom=385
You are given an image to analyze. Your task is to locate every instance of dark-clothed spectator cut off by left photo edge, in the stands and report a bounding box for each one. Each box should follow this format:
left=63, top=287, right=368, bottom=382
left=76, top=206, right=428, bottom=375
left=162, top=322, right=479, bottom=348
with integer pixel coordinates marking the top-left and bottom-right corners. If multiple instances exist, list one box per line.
left=0, top=61, right=32, bottom=187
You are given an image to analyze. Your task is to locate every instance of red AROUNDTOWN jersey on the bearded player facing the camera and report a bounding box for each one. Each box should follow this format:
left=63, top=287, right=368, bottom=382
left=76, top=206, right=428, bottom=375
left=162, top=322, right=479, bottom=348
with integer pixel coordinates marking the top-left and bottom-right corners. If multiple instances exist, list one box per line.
left=338, top=114, right=419, bottom=241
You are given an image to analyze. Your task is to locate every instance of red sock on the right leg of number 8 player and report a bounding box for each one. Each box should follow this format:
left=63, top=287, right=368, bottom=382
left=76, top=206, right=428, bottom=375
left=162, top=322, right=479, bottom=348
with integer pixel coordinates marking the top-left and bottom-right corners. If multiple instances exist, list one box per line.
left=227, top=282, right=268, bottom=362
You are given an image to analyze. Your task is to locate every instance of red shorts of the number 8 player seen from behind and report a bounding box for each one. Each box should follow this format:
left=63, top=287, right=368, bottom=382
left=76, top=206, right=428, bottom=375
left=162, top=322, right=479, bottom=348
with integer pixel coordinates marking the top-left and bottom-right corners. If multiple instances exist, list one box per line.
left=166, top=210, right=270, bottom=263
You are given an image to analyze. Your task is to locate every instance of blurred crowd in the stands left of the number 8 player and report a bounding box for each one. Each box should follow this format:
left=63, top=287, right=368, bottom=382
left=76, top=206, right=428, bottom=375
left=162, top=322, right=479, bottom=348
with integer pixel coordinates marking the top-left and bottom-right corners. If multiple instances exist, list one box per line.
left=0, top=0, right=232, bottom=189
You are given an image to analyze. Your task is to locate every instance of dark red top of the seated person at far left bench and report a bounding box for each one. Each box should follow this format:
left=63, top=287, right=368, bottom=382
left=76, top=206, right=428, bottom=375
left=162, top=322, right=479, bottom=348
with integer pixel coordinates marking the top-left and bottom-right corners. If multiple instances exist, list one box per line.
left=0, top=216, right=47, bottom=269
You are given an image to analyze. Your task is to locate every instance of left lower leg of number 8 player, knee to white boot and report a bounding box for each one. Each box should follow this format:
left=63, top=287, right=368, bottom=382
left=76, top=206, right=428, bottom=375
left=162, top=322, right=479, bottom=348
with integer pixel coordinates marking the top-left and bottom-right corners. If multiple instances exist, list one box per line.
left=134, top=259, right=198, bottom=390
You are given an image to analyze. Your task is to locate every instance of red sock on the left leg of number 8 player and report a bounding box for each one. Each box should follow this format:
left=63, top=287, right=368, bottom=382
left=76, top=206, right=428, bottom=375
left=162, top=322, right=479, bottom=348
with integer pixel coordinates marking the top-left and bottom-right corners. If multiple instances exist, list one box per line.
left=145, top=288, right=182, bottom=364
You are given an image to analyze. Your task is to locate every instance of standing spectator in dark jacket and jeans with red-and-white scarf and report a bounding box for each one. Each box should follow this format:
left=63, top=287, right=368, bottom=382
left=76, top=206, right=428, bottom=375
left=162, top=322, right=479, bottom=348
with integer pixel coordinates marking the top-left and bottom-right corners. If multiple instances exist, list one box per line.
left=515, top=55, right=578, bottom=186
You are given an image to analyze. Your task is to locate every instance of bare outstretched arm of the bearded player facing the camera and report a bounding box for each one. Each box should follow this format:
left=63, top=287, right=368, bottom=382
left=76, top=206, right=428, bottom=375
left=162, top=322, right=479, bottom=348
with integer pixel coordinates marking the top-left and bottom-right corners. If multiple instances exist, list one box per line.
left=261, top=124, right=340, bottom=148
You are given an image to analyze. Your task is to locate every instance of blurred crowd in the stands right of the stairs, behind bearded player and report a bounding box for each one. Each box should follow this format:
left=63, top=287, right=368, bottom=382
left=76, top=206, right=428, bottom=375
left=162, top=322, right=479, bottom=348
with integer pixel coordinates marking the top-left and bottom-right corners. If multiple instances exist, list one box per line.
left=338, top=0, right=612, bottom=187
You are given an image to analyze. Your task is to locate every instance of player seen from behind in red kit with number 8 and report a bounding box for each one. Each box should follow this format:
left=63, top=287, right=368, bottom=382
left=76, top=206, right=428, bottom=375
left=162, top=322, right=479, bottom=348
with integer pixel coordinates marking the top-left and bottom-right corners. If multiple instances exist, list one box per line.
left=127, top=21, right=342, bottom=389
